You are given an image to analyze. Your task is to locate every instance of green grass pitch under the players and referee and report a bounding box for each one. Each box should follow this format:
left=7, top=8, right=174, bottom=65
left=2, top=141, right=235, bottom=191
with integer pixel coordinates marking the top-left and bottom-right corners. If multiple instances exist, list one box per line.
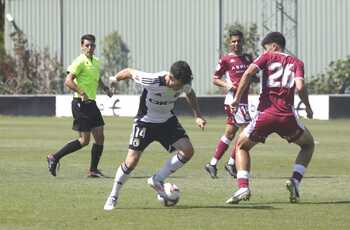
left=0, top=117, right=350, bottom=230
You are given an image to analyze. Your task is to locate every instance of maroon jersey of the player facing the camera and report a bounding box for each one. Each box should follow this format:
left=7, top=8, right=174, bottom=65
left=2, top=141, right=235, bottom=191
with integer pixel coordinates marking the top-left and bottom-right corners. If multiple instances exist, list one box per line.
left=214, top=53, right=251, bottom=104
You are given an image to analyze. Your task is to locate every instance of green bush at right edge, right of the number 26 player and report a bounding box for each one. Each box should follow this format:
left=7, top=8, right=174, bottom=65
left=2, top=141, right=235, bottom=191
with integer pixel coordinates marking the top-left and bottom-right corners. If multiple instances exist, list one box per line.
left=308, top=56, right=350, bottom=94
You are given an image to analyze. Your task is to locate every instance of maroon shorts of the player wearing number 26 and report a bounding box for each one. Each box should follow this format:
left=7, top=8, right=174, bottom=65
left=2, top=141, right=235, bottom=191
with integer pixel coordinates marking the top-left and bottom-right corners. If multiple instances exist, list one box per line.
left=244, top=112, right=304, bottom=143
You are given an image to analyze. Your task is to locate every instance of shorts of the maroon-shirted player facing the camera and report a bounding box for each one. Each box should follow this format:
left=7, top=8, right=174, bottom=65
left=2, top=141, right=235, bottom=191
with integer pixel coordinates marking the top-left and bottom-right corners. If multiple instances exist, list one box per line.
left=224, top=104, right=252, bottom=126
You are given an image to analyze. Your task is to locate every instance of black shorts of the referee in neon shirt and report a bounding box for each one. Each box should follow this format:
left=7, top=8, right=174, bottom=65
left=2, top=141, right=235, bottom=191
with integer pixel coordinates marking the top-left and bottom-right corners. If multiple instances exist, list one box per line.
left=72, top=98, right=105, bottom=132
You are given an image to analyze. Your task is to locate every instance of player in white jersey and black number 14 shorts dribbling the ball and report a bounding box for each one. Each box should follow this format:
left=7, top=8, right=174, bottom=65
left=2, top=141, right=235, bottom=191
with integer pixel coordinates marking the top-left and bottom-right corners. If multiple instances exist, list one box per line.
left=104, top=61, right=206, bottom=210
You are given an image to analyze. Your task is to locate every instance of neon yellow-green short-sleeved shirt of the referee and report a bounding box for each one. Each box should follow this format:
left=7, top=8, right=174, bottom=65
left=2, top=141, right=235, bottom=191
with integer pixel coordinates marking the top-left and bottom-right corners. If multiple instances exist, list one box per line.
left=67, top=54, right=100, bottom=100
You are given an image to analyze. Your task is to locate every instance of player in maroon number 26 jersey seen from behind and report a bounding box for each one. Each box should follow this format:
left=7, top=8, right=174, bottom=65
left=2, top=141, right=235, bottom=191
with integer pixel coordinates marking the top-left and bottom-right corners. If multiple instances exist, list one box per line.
left=226, top=32, right=314, bottom=204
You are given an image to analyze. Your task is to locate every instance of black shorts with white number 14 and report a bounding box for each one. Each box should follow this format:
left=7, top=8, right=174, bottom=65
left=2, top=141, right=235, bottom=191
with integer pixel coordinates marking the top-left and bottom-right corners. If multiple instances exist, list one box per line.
left=129, top=116, right=188, bottom=152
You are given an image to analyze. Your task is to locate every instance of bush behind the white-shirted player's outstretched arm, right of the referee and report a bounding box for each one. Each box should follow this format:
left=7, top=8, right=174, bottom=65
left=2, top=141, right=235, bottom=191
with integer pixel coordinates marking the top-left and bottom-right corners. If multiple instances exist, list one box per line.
left=102, top=31, right=136, bottom=94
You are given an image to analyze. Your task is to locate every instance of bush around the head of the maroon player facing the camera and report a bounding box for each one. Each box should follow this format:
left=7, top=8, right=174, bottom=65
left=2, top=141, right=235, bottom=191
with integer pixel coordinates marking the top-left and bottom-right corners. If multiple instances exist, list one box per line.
left=224, top=22, right=260, bottom=58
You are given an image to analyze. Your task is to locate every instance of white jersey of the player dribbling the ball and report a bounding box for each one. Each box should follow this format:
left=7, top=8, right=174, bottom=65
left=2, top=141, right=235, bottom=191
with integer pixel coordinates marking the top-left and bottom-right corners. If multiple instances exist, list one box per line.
left=132, top=70, right=192, bottom=123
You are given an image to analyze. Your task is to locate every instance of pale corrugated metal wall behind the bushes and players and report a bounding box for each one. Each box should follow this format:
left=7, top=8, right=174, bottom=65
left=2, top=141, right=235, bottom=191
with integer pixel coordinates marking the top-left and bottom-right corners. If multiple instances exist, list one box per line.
left=6, top=0, right=350, bottom=95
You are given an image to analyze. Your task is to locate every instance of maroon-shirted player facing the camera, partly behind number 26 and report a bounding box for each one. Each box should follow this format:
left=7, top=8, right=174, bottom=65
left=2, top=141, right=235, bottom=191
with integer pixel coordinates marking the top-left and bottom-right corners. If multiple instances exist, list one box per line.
left=204, top=30, right=251, bottom=178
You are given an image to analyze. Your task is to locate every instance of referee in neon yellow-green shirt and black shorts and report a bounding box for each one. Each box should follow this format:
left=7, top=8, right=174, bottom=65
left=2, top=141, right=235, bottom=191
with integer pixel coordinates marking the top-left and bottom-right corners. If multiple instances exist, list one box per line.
left=47, top=34, right=112, bottom=177
